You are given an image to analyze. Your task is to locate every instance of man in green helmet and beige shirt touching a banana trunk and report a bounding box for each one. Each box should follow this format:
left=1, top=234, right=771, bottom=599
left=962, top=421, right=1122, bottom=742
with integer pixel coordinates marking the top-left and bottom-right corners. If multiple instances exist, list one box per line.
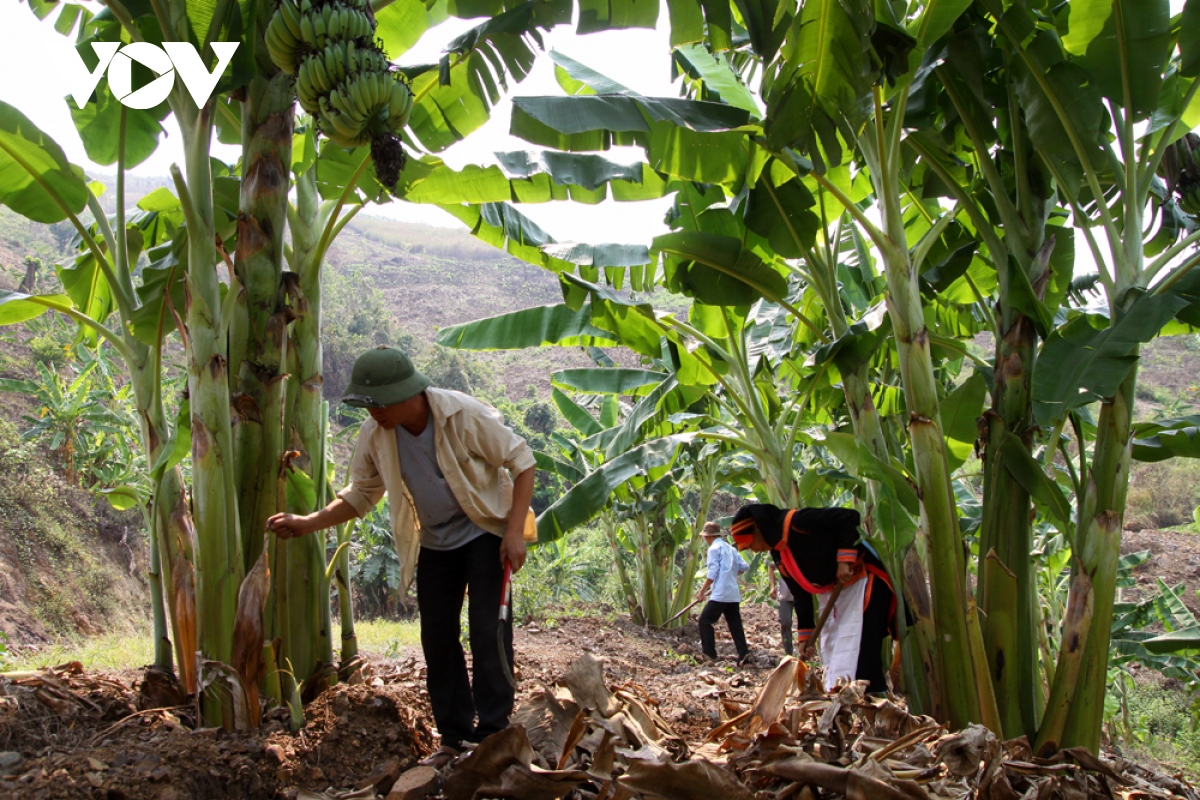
left=266, top=347, right=534, bottom=759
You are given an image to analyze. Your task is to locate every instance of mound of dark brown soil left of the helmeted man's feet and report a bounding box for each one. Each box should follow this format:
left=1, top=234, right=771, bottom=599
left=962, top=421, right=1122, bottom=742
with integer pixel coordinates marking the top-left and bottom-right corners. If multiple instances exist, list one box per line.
left=0, top=664, right=432, bottom=800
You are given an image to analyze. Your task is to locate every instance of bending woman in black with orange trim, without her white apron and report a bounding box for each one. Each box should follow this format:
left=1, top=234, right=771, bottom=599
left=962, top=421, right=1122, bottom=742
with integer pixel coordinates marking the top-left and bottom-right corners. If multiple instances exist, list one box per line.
left=731, top=503, right=896, bottom=692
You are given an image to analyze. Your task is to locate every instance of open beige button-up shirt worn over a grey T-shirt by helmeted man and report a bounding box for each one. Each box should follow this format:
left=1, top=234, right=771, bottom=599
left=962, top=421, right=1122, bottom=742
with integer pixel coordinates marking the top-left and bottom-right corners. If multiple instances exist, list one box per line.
left=337, top=389, right=535, bottom=593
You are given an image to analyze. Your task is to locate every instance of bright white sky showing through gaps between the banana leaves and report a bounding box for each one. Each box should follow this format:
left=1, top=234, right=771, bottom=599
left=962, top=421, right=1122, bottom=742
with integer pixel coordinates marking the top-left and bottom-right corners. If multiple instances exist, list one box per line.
left=0, top=0, right=678, bottom=242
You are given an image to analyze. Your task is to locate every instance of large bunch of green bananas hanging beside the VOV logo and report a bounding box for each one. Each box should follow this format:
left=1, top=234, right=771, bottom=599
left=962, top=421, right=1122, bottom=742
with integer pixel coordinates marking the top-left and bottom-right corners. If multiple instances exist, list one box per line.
left=265, top=0, right=413, bottom=187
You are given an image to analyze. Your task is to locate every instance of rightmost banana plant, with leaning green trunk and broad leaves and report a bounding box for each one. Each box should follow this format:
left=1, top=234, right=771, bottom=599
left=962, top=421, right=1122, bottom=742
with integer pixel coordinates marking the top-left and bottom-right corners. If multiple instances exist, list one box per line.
left=969, top=0, right=1200, bottom=751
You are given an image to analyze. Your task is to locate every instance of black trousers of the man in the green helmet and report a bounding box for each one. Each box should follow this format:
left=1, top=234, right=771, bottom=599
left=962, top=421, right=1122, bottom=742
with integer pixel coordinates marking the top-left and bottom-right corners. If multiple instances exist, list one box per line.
left=416, top=534, right=514, bottom=747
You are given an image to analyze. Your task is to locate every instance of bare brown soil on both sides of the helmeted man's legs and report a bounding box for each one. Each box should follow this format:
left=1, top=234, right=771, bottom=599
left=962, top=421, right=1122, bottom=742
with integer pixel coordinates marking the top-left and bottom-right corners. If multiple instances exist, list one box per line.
left=0, top=606, right=781, bottom=800
